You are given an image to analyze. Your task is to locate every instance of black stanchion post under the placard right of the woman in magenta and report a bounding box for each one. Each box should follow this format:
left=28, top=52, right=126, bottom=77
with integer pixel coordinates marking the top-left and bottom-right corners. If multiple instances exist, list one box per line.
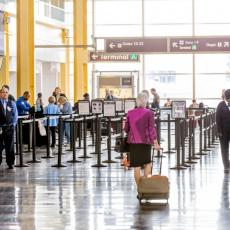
left=170, top=118, right=186, bottom=170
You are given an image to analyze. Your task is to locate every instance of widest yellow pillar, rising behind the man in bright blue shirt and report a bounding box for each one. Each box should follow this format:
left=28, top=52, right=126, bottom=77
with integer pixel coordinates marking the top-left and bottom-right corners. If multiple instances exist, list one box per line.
left=17, top=0, right=35, bottom=104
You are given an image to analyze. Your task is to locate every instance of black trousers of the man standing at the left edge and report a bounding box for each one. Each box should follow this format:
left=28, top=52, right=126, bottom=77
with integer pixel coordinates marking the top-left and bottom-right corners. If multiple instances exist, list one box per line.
left=0, top=126, right=15, bottom=166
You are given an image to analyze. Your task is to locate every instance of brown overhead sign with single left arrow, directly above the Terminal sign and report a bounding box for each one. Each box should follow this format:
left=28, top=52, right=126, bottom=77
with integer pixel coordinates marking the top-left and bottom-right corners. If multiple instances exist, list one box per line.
left=105, top=38, right=167, bottom=53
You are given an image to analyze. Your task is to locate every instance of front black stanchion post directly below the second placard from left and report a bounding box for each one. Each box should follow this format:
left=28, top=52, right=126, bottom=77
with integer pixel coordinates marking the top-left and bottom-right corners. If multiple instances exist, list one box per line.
left=92, top=115, right=106, bottom=168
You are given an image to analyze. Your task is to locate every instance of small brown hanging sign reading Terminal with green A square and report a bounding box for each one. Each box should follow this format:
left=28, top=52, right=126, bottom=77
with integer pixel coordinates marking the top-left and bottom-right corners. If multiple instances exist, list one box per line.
left=89, top=52, right=140, bottom=62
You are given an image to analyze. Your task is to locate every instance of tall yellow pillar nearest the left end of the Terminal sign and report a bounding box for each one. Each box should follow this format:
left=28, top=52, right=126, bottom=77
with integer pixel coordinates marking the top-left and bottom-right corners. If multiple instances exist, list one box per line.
left=73, top=0, right=88, bottom=102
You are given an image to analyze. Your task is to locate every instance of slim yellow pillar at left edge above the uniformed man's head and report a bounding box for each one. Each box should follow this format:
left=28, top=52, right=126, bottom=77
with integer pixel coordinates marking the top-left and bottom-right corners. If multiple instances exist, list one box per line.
left=0, top=12, right=10, bottom=86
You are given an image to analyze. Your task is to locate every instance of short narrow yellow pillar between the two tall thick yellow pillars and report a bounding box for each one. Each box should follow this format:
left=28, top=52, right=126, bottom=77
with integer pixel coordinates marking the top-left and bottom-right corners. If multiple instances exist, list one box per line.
left=60, top=29, right=70, bottom=98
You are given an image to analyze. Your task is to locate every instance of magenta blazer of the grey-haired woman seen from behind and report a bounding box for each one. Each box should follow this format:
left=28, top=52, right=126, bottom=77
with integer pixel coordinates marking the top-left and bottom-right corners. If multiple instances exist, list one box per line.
left=124, top=107, right=157, bottom=144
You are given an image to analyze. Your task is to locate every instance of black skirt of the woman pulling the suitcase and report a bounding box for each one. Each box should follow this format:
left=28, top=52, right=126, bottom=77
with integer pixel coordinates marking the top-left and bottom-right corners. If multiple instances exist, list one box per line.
left=129, top=144, right=152, bottom=167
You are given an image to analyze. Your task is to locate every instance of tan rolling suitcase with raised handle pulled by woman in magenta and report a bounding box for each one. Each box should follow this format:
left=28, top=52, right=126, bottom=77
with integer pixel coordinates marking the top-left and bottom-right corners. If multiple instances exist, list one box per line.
left=137, top=151, right=169, bottom=204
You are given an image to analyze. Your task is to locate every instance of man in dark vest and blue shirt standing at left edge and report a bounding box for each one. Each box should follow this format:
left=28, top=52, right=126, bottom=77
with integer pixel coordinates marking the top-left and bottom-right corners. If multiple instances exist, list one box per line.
left=0, top=87, right=18, bottom=169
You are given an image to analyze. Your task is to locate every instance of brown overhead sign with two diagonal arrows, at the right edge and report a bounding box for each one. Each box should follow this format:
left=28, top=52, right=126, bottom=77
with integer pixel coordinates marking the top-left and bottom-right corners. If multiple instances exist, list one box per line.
left=170, top=37, right=230, bottom=53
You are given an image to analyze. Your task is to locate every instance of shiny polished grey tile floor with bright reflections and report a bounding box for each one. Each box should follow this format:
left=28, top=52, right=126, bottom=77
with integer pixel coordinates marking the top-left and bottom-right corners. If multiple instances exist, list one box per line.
left=0, top=139, right=230, bottom=230
